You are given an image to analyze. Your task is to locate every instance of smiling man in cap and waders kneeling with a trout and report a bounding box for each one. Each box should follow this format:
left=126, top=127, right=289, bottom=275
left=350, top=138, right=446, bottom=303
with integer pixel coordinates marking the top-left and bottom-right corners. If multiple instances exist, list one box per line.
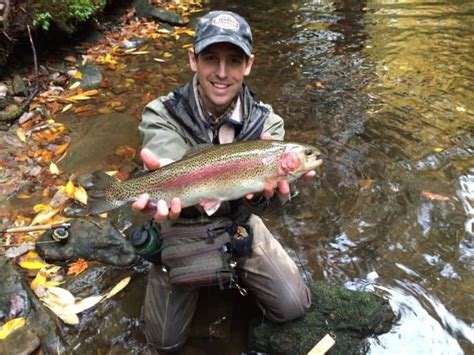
left=133, top=11, right=314, bottom=351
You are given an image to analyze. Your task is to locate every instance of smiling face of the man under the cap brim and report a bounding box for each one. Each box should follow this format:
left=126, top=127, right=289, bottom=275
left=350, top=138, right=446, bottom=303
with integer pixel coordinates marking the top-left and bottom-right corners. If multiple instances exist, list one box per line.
left=188, top=43, right=254, bottom=114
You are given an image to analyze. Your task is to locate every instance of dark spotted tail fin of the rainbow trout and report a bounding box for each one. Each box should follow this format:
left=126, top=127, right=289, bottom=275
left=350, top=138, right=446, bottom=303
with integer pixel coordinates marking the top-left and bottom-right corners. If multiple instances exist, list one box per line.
left=86, top=171, right=118, bottom=214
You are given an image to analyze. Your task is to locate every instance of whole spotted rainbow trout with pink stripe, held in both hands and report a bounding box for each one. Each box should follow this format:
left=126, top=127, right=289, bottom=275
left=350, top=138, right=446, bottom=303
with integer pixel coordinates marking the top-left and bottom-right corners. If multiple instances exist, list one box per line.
left=87, top=140, right=322, bottom=215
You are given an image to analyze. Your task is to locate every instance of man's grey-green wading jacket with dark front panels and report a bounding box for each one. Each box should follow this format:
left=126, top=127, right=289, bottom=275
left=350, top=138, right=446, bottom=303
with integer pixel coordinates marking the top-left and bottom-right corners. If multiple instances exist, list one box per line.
left=139, top=77, right=285, bottom=215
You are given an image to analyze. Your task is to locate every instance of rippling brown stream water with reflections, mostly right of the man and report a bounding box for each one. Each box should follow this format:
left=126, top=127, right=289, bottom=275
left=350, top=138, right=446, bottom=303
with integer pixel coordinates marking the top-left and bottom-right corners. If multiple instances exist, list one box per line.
left=5, top=0, right=474, bottom=354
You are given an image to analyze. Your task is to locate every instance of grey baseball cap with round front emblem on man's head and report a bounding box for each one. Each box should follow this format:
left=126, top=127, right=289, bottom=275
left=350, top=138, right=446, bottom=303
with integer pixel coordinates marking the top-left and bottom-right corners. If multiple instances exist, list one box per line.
left=194, top=11, right=252, bottom=57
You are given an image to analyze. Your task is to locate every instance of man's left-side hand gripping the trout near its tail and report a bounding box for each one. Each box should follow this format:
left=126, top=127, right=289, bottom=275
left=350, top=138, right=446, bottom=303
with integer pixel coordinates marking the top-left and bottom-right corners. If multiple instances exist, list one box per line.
left=132, top=148, right=181, bottom=223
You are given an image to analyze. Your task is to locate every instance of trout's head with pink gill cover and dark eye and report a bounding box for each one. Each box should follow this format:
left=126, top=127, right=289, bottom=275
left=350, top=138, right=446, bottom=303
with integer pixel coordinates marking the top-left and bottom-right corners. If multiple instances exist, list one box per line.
left=278, top=143, right=323, bottom=178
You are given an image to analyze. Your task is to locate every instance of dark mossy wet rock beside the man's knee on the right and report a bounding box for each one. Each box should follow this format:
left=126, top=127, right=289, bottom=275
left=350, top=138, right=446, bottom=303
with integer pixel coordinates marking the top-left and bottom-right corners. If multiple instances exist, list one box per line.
left=249, top=282, right=395, bottom=355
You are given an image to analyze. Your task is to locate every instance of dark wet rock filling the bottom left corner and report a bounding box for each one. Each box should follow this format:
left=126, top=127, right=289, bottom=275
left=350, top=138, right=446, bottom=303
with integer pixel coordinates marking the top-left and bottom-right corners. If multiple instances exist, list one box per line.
left=0, top=257, right=67, bottom=354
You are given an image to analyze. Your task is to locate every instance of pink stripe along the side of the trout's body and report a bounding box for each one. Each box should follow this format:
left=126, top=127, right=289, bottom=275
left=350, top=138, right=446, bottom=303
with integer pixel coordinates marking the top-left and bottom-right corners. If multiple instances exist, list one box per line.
left=159, top=159, right=262, bottom=190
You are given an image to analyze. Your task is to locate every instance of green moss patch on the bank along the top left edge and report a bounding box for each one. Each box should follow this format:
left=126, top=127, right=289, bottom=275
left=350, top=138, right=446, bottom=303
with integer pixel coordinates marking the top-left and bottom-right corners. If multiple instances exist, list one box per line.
left=32, top=0, right=108, bottom=34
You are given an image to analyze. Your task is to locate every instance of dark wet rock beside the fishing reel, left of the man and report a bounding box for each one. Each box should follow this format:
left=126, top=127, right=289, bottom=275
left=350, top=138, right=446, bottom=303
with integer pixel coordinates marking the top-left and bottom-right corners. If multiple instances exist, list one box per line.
left=36, top=218, right=138, bottom=266
